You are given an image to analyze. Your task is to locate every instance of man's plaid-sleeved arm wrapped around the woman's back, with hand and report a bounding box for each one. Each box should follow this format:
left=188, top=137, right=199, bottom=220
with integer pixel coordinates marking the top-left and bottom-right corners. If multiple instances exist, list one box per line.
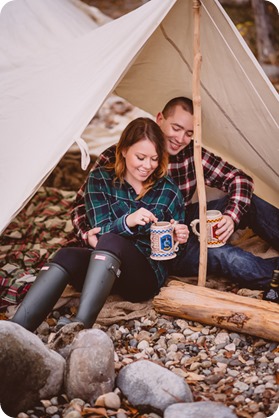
left=71, top=145, right=116, bottom=246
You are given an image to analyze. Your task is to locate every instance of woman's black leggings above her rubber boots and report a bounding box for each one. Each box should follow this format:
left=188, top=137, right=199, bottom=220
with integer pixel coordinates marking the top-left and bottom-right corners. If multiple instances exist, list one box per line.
left=51, top=233, right=159, bottom=302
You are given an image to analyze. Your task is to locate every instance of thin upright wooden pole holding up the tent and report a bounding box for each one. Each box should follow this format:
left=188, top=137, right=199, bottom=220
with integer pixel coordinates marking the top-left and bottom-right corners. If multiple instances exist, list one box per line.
left=192, top=0, right=207, bottom=286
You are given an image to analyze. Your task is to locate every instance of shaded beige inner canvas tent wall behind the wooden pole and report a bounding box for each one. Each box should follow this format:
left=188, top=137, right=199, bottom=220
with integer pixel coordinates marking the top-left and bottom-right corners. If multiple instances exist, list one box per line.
left=116, top=0, right=279, bottom=206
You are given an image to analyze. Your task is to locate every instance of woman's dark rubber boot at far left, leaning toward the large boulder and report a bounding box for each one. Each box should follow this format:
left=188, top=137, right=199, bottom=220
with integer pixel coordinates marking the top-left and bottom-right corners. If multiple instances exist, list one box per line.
left=11, top=263, right=69, bottom=332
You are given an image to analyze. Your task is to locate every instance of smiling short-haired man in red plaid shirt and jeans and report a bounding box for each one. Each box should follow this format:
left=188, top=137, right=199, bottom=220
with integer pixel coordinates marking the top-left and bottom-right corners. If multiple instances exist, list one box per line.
left=72, top=97, right=279, bottom=296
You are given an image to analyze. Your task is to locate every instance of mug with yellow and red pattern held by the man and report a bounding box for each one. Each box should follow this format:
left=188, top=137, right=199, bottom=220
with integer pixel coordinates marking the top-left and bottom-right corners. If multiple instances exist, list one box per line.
left=190, top=210, right=225, bottom=248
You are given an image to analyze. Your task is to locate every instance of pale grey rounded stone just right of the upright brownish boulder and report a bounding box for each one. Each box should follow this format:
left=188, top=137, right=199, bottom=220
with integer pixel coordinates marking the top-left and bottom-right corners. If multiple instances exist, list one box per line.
left=116, top=360, right=193, bottom=413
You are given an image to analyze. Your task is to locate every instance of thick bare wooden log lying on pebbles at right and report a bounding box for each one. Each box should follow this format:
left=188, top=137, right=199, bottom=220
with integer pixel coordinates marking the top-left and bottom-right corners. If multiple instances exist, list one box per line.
left=153, top=280, right=279, bottom=341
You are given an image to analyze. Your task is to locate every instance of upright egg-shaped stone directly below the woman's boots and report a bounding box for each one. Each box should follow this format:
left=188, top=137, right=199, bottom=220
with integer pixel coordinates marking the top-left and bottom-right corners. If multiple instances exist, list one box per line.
left=64, top=329, right=115, bottom=405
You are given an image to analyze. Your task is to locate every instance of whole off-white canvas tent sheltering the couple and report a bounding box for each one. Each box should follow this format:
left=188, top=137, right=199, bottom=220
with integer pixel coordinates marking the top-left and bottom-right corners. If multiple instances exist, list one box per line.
left=0, top=0, right=279, bottom=232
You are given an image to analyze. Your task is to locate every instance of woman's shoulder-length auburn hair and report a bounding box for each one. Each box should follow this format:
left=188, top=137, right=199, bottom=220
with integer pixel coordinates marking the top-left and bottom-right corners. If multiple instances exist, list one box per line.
left=106, top=117, right=168, bottom=199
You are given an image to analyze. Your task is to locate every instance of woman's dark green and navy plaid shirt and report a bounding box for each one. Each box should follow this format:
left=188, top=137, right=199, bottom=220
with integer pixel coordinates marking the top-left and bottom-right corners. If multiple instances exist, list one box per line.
left=85, top=167, right=185, bottom=286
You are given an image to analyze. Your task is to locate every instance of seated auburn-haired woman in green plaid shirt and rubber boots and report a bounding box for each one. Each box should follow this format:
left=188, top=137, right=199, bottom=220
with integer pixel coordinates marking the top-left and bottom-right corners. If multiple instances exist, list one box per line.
left=12, top=118, right=188, bottom=331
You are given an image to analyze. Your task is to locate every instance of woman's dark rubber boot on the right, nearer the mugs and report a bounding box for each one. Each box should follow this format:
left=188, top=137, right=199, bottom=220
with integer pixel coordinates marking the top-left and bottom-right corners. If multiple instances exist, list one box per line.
left=56, top=250, right=120, bottom=330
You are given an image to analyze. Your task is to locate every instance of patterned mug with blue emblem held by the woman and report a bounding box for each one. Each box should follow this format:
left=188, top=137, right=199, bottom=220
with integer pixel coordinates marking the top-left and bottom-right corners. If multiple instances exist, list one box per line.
left=150, top=222, right=179, bottom=260
